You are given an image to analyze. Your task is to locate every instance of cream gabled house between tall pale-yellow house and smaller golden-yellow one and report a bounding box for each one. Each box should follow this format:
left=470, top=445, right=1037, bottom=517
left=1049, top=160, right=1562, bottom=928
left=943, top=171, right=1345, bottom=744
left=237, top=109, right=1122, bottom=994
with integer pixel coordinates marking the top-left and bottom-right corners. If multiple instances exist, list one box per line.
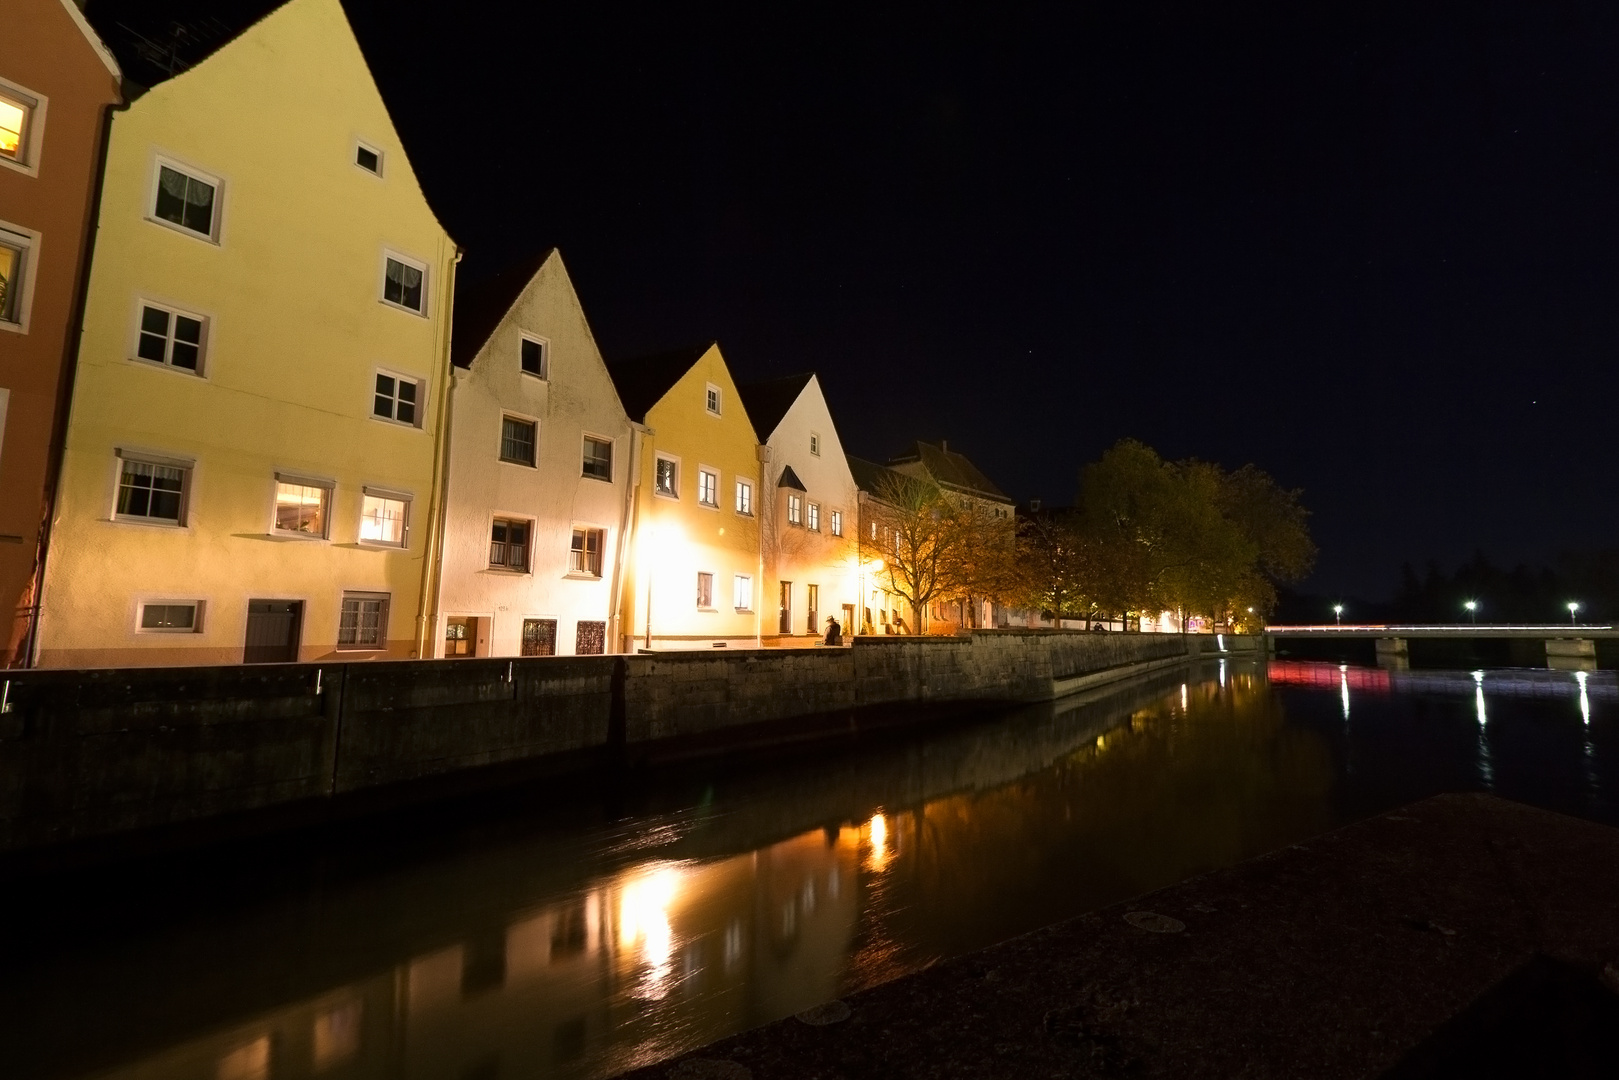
left=436, top=251, right=638, bottom=657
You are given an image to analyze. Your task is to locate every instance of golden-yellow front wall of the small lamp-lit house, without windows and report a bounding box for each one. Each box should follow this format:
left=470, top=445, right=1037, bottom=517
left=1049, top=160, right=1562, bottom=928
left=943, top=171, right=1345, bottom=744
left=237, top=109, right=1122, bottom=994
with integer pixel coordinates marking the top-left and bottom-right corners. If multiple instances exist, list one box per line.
left=622, top=345, right=774, bottom=651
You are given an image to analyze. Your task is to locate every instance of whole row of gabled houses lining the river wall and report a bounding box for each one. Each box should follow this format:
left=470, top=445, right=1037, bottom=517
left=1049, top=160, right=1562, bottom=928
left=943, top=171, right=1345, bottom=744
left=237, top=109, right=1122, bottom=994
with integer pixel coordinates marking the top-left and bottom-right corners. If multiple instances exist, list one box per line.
left=0, top=0, right=1012, bottom=667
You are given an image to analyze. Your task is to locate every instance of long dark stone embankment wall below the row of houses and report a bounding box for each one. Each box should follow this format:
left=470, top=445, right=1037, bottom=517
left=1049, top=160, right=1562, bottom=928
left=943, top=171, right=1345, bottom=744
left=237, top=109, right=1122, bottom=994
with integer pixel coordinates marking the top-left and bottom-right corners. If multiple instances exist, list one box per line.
left=0, top=630, right=1258, bottom=852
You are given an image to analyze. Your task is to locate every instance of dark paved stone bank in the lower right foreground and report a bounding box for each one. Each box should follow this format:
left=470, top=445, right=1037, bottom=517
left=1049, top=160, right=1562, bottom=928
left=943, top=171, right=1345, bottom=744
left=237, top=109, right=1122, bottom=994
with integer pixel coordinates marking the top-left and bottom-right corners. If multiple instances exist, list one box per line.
left=615, top=795, right=1619, bottom=1080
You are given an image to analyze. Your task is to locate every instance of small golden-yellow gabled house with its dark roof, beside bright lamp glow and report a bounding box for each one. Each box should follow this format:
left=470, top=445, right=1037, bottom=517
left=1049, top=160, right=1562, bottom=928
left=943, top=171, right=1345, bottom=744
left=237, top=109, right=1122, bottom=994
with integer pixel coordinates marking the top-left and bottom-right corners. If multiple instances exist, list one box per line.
left=607, top=345, right=767, bottom=653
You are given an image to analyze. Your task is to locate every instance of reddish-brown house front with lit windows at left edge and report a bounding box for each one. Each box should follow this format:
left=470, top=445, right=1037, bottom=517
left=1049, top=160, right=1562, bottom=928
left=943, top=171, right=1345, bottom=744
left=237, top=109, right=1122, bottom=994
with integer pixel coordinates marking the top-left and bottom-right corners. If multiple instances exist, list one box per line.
left=0, top=0, right=121, bottom=665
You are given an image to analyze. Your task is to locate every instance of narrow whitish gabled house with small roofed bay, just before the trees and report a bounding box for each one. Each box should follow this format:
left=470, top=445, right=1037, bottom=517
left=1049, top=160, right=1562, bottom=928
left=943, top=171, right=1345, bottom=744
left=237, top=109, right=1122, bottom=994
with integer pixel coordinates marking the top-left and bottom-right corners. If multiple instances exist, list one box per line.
left=740, top=374, right=861, bottom=644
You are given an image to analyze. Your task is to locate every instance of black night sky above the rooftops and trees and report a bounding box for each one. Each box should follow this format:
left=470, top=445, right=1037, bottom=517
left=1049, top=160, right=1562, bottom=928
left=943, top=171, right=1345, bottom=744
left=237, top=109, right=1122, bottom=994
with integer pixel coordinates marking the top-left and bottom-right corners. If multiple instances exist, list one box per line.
left=92, top=0, right=1619, bottom=594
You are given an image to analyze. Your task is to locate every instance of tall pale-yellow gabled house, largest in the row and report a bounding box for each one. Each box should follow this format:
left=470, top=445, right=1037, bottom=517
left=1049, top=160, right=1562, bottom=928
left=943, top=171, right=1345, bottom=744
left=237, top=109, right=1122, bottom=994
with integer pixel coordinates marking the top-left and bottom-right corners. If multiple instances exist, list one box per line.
left=39, top=0, right=457, bottom=667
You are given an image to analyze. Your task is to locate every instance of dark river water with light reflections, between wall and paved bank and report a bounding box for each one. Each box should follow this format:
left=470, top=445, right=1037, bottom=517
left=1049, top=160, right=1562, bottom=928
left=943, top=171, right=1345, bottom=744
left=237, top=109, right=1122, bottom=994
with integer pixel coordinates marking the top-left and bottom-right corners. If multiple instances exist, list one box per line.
left=0, top=662, right=1619, bottom=1080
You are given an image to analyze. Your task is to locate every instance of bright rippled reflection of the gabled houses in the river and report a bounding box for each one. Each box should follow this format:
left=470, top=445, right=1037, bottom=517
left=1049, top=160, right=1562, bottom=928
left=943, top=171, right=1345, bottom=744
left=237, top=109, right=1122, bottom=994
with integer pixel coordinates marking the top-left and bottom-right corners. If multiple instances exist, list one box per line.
left=93, top=827, right=863, bottom=1080
